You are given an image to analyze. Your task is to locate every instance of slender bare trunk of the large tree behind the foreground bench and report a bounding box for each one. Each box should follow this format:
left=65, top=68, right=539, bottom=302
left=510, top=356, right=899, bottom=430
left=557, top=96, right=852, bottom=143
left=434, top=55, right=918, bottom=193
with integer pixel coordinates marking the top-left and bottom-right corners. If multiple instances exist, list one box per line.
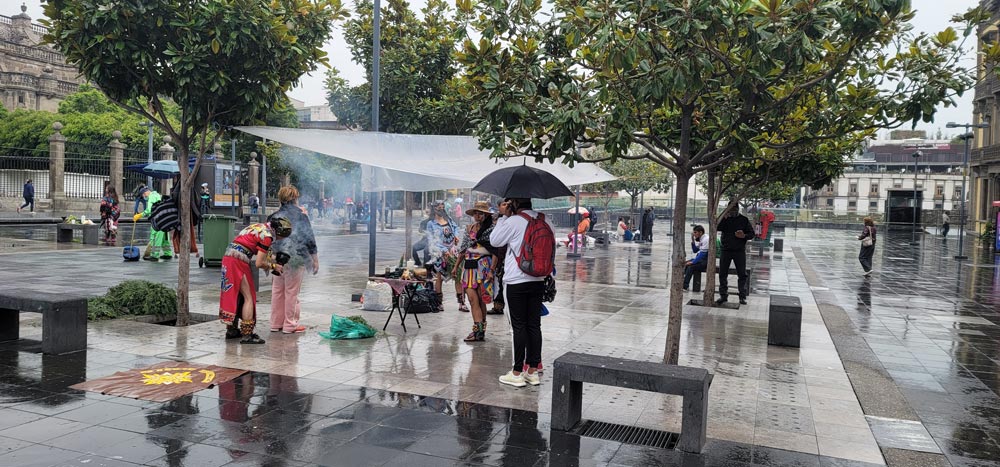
left=663, top=173, right=691, bottom=365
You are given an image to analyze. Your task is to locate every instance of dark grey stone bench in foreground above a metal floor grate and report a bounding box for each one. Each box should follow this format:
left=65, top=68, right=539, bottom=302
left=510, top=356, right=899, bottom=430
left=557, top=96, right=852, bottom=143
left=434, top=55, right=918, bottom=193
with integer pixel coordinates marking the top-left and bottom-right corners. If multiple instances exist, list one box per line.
left=552, top=352, right=712, bottom=453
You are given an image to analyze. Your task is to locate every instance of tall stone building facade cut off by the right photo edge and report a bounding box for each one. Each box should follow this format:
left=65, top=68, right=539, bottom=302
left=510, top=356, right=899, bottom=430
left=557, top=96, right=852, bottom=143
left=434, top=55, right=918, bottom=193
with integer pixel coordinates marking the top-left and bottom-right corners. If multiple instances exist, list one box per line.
left=969, top=0, right=1000, bottom=231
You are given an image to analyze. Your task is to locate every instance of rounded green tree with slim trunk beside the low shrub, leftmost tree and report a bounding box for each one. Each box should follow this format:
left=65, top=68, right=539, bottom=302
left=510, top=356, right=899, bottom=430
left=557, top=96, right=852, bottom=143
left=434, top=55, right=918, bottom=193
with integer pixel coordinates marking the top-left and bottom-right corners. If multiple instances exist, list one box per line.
left=43, top=0, right=344, bottom=326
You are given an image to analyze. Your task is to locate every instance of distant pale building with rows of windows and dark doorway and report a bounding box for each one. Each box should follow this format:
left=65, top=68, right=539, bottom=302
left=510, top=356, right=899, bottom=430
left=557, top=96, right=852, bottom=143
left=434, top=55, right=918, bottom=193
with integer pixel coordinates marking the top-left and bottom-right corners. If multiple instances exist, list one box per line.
left=803, top=140, right=965, bottom=223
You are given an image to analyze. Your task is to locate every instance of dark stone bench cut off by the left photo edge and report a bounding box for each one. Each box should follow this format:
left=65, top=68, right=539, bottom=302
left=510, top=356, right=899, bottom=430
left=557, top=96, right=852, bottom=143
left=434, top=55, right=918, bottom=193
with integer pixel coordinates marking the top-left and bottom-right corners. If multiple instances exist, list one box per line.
left=0, top=289, right=87, bottom=354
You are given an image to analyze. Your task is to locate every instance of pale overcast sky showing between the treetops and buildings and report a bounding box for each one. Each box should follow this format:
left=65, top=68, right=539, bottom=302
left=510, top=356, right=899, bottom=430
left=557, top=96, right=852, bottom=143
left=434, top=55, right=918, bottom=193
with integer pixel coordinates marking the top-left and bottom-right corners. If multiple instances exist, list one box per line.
left=19, top=0, right=979, bottom=139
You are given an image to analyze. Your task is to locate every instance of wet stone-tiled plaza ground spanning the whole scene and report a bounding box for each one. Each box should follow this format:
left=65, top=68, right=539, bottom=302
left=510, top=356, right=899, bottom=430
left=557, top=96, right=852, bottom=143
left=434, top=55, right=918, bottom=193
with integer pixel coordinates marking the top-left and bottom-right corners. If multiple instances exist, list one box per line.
left=0, top=223, right=1000, bottom=466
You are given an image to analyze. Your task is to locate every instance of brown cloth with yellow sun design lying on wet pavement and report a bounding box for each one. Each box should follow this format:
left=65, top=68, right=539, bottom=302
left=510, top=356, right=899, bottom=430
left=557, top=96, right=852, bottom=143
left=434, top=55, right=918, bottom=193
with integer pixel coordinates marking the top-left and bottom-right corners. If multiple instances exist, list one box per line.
left=70, top=362, right=246, bottom=402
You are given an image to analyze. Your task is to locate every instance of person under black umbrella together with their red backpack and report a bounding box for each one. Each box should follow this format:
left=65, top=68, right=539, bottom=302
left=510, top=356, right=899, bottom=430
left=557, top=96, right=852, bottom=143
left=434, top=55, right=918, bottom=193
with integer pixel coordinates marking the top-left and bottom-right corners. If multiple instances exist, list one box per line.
left=490, top=198, right=556, bottom=387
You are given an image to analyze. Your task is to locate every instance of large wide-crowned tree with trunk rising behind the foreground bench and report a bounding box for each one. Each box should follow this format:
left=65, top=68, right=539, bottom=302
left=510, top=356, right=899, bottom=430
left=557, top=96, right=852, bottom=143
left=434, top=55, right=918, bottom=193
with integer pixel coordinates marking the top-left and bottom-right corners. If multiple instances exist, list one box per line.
left=457, top=0, right=982, bottom=363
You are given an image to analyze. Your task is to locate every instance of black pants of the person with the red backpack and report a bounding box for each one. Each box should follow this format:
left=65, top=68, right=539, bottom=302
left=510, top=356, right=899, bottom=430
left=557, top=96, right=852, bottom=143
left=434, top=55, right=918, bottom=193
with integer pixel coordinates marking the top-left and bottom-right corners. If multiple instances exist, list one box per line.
left=504, top=281, right=545, bottom=372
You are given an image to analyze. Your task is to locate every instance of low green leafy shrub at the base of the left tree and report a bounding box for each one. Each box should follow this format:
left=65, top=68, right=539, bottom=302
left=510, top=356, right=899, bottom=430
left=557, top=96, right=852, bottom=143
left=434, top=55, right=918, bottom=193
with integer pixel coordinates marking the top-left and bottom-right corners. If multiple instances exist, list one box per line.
left=87, top=280, right=177, bottom=321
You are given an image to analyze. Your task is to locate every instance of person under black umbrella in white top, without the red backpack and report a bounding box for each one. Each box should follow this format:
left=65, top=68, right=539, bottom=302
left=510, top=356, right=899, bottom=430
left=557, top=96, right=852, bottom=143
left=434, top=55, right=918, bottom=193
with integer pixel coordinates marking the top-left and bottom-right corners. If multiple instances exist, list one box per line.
left=490, top=198, right=555, bottom=387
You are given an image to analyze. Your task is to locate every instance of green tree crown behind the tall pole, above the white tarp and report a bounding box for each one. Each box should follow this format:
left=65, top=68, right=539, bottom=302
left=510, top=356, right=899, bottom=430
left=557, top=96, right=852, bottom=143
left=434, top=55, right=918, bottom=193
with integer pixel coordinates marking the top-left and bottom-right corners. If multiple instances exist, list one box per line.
left=326, top=0, right=471, bottom=135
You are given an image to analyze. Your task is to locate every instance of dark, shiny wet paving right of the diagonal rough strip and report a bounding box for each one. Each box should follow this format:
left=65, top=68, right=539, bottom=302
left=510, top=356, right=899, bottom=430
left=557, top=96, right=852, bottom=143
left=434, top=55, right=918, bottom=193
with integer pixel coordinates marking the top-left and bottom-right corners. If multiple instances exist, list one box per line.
left=796, top=231, right=1000, bottom=465
